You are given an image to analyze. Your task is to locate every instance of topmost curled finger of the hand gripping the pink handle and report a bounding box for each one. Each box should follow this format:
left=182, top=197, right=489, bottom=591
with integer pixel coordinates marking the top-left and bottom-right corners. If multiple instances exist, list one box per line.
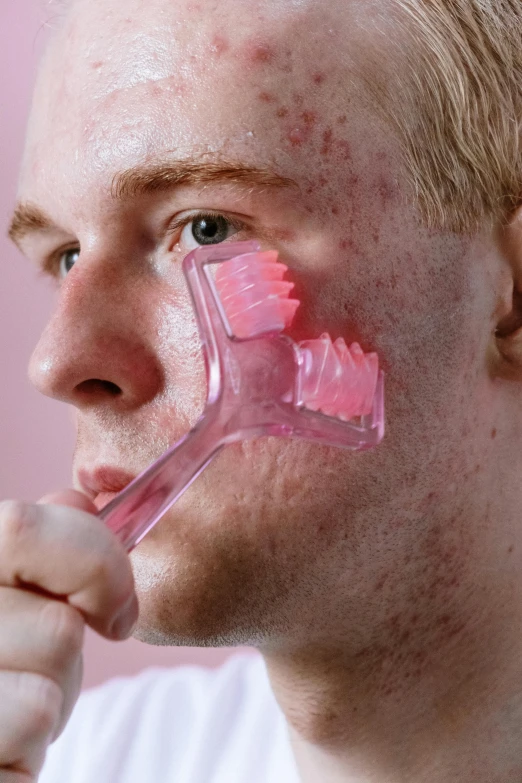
left=0, top=501, right=138, bottom=638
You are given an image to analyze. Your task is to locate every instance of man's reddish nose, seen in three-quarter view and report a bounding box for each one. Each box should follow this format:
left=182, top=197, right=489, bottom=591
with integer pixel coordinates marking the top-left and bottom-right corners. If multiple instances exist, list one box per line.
left=29, top=259, right=164, bottom=411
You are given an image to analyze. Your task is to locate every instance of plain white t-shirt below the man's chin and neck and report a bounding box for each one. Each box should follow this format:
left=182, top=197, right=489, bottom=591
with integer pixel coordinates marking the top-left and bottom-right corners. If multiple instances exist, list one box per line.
left=38, top=654, right=299, bottom=783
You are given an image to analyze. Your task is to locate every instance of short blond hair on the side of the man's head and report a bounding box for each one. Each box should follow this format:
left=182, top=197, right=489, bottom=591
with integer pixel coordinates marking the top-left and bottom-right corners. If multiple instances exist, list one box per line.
left=381, top=0, right=522, bottom=233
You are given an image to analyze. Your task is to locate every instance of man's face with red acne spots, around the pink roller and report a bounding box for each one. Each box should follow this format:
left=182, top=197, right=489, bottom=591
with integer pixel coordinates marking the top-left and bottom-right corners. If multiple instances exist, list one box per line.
left=20, top=0, right=506, bottom=649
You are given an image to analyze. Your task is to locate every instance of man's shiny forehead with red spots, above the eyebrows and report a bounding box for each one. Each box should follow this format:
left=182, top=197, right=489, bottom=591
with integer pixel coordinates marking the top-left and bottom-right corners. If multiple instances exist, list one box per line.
left=21, top=0, right=394, bottom=208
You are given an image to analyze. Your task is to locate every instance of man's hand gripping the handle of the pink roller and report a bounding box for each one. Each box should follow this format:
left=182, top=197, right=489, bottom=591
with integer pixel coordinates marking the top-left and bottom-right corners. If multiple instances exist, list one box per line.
left=0, top=490, right=138, bottom=783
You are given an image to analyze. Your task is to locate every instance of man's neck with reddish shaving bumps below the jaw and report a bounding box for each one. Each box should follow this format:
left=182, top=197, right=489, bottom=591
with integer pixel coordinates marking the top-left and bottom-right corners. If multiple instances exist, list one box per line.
left=264, top=568, right=522, bottom=783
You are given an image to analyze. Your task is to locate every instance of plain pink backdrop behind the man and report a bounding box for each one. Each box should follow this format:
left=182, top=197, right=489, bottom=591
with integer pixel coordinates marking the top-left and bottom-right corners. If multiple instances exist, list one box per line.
left=0, top=0, right=238, bottom=687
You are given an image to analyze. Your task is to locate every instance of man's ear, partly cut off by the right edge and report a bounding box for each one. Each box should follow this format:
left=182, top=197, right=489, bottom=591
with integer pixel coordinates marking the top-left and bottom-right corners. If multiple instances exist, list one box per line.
left=495, top=206, right=522, bottom=381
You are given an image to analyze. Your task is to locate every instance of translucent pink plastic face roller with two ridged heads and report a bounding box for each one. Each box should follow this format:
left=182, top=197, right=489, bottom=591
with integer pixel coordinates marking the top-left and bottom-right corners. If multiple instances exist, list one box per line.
left=99, top=242, right=384, bottom=551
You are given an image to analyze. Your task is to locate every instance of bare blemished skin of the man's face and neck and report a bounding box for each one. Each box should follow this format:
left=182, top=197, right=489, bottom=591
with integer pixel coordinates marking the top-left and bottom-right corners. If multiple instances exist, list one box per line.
left=13, top=0, right=522, bottom=783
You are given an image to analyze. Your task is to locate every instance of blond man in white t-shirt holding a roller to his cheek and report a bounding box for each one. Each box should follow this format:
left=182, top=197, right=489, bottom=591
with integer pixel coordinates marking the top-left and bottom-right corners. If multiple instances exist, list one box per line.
left=0, top=0, right=522, bottom=783
